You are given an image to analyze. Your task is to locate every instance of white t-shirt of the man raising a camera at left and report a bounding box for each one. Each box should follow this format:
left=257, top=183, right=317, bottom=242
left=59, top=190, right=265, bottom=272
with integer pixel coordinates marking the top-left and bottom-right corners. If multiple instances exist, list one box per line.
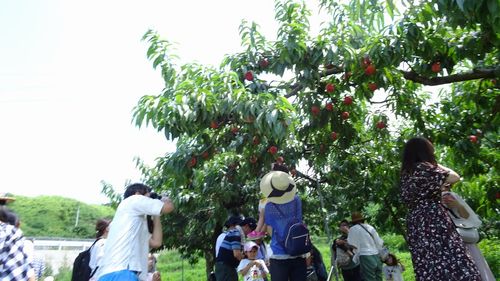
left=97, top=195, right=163, bottom=280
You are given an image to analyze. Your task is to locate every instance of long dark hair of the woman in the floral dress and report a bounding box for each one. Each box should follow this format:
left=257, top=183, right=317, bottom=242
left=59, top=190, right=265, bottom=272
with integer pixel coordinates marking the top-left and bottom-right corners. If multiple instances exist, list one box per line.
left=401, top=137, right=437, bottom=174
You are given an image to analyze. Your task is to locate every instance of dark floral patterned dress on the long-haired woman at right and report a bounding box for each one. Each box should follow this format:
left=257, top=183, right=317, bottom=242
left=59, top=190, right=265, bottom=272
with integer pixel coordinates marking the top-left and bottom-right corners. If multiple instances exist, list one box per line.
left=401, top=163, right=481, bottom=281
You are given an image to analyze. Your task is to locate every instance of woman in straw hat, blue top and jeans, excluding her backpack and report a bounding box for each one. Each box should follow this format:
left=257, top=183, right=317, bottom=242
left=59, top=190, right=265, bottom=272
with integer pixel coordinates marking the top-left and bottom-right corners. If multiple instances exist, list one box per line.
left=260, top=166, right=307, bottom=281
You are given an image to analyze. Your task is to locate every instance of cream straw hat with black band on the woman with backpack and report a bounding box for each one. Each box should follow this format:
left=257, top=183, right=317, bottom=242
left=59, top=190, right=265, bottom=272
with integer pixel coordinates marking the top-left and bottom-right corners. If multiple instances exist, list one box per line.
left=260, top=171, right=297, bottom=204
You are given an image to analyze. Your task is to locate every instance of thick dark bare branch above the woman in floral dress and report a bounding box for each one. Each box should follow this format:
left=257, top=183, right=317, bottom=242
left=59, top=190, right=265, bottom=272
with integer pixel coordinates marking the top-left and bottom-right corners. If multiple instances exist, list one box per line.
left=401, top=69, right=495, bottom=86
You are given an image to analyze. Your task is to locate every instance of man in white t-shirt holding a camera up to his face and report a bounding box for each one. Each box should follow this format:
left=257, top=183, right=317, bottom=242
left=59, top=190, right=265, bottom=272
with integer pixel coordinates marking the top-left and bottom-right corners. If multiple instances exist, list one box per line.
left=97, top=183, right=174, bottom=281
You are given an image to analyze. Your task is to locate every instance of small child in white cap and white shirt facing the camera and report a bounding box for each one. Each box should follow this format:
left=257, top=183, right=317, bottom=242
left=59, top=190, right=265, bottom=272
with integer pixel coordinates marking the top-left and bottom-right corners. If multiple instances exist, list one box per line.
left=238, top=241, right=269, bottom=281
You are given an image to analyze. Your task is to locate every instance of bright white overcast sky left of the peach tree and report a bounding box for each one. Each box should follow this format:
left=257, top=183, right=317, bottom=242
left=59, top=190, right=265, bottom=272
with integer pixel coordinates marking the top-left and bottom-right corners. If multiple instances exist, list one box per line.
left=0, top=0, right=300, bottom=203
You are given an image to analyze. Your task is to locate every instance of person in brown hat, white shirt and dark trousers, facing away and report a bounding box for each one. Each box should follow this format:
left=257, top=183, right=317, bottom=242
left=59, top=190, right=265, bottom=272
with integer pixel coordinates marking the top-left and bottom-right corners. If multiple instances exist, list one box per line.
left=347, top=212, right=384, bottom=281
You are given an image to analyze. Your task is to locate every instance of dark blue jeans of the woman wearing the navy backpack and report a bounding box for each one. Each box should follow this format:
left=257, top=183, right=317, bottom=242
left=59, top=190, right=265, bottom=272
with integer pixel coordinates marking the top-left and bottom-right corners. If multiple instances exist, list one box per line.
left=270, top=258, right=307, bottom=281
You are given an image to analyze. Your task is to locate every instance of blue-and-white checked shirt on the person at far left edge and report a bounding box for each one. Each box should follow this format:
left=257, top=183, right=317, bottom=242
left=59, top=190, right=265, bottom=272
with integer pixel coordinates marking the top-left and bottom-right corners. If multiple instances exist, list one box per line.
left=0, top=221, right=31, bottom=281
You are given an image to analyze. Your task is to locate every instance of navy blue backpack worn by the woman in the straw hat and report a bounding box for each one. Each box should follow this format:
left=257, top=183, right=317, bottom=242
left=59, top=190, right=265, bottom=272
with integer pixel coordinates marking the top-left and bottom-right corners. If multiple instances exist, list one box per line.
left=275, top=201, right=312, bottom=256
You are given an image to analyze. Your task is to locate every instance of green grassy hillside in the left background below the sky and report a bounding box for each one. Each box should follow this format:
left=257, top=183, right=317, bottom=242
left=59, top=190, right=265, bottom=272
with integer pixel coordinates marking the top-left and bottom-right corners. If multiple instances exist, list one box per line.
left=8, top=195, right=114, bottom=238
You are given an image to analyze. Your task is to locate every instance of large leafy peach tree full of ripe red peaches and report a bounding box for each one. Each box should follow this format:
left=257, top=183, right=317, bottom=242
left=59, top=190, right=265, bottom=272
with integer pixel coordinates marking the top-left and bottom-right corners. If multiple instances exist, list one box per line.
left=134, top=0, right=500, bottom=272
